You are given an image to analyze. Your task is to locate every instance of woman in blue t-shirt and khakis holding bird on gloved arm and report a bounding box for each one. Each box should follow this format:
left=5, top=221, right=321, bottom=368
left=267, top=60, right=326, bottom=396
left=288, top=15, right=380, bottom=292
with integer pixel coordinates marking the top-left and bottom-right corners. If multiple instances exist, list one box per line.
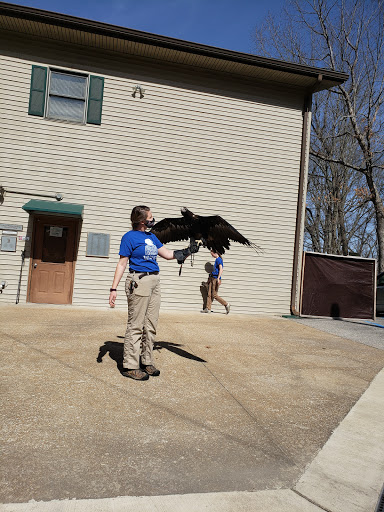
left=109, top=206, right=198, bottom=380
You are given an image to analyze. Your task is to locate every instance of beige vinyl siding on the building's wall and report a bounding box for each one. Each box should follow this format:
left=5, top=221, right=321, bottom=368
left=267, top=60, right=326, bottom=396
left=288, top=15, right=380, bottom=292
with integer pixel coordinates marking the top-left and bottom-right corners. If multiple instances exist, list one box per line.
left=0, top=36, right=302, bottom=314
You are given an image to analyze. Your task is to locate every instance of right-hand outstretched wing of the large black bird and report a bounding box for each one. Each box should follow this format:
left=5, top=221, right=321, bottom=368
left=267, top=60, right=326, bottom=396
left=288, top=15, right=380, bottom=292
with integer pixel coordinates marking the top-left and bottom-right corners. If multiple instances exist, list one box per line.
left=200, top=215, right=263, bottom=254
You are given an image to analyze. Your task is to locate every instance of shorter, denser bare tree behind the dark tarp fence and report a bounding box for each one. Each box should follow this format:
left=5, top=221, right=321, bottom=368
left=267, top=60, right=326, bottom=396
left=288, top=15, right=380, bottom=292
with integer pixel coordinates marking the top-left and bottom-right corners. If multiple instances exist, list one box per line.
left=305, top=91, right=375, bottom=256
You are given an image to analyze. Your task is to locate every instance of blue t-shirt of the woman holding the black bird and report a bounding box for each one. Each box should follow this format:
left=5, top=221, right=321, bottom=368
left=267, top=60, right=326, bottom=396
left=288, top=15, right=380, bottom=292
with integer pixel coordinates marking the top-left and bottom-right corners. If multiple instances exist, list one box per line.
left=119, top=230, right=163, bottom=272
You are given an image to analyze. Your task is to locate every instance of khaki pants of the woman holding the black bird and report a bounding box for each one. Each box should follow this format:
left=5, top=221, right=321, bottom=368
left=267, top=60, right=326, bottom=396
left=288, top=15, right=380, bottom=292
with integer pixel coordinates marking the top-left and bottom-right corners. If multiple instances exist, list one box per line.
left=123, top=273, right=161, bottom=370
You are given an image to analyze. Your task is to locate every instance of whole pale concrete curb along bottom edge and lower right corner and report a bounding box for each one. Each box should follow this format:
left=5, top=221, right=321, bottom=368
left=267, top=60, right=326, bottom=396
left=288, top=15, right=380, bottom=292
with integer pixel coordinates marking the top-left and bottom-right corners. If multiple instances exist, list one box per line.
left=0, top=370, right=384, bottom=512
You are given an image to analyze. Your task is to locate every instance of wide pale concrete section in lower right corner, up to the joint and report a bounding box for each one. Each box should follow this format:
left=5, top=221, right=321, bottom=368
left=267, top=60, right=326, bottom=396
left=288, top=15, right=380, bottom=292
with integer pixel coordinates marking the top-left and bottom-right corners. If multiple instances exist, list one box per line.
left=295, top=370, right=384, bottom=512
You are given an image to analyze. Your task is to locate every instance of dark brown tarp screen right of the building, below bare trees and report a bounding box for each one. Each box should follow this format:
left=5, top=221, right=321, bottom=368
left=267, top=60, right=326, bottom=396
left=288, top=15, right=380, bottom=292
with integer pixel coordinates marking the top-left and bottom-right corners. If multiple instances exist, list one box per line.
left=300, top=252, right=376, bottom=318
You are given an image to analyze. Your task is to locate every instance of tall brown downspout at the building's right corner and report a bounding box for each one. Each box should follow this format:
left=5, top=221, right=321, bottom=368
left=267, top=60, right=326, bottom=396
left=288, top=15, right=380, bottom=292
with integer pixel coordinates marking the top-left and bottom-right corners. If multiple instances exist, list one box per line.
left=291, top=75, right=323, bottom=316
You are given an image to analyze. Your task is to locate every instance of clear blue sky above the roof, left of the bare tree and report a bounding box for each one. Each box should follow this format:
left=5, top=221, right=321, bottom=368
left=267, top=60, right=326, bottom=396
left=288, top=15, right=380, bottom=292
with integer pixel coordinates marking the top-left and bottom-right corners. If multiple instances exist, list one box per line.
left=10, top=0, right=285, bottom=53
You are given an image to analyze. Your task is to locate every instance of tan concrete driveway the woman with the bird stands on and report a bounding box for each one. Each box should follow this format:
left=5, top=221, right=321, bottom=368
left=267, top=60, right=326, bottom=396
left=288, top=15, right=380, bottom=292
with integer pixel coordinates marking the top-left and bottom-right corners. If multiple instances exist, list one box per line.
left=0, top=305, right=384, bottom=510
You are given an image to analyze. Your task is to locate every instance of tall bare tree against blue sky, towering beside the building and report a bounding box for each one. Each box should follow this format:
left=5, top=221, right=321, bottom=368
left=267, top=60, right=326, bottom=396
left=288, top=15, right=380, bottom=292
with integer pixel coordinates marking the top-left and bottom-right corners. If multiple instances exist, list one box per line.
left=256, top=0, right=384, bottom=272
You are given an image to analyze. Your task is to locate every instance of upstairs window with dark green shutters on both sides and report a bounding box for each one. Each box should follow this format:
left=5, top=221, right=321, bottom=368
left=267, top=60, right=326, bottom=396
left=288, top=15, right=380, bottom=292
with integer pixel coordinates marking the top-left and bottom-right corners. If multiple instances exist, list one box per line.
left=28, top=66, right=104, bottom=124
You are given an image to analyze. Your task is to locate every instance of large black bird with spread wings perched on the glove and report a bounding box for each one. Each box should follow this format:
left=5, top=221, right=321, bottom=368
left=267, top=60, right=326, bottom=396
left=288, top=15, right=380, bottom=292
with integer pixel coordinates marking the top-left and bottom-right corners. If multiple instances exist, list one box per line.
left=151, top=207, right=262, bottom=254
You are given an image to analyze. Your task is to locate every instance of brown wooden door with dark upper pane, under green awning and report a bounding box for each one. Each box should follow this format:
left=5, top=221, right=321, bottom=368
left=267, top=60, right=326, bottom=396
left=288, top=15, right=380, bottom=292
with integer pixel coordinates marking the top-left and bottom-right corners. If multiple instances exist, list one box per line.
left=29, top=216, right=78, bottom=304
